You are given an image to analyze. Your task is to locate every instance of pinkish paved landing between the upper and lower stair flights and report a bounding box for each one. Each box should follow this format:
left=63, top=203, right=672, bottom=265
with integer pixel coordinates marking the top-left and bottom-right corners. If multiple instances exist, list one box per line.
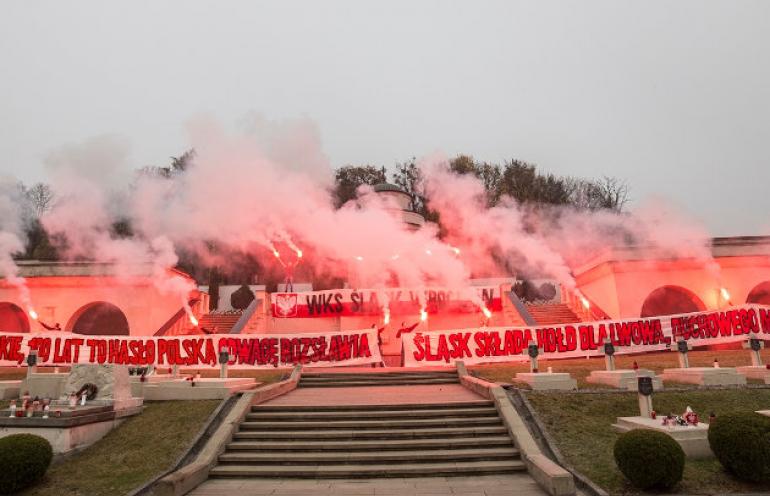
left=261, top=384, right=484, bottom=406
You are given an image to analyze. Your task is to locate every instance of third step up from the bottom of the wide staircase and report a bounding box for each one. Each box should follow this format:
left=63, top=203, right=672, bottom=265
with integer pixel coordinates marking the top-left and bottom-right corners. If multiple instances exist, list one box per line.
left=227, top=435, right=513, bottom=452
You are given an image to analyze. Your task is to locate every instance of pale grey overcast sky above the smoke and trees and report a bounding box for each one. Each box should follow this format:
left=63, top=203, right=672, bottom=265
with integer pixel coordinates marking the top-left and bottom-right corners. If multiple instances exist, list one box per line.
left=0, top=0, right=770, bottom=235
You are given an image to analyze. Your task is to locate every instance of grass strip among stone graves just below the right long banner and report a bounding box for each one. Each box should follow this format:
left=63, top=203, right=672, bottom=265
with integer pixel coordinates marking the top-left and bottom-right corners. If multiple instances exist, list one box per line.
left=469, top=349, right=770, bottom=389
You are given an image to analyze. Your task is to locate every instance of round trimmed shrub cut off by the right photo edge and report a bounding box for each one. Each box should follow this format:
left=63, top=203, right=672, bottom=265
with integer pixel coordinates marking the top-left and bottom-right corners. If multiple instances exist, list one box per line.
left=709, top=412, right=770, bottom=482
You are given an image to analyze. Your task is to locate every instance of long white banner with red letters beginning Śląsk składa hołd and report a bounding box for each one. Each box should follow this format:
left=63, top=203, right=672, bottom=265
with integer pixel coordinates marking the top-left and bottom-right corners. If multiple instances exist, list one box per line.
left=403, top=305, right=770, bottom=367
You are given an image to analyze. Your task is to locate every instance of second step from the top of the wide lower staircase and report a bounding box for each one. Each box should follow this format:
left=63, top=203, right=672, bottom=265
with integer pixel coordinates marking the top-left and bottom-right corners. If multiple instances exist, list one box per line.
left=246, top=406, right=497, bottom=421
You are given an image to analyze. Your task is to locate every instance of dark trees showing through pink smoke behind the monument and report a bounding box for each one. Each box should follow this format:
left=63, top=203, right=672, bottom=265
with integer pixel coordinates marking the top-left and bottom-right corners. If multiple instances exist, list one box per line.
left=15, top=150, right=629, bottom=305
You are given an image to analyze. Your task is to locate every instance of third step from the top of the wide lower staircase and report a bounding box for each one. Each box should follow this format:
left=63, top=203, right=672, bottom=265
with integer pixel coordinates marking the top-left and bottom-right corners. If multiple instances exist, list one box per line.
left=241, top=417, right=501, bottom=430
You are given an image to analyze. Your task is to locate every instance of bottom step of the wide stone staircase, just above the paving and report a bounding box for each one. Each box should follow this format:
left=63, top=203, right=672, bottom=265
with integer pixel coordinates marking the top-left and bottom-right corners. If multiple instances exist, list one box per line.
left=209, top=460, right=526, bottom=479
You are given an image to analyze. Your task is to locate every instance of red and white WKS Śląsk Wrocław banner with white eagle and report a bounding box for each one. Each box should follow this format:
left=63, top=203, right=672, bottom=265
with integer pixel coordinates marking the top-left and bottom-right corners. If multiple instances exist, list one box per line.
left=270, top=286, right=502, bottom=318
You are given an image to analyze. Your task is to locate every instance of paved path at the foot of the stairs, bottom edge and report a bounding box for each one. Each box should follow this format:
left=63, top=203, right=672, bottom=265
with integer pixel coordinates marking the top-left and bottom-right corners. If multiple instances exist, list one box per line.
left=189, top=473, right=547, bottom=496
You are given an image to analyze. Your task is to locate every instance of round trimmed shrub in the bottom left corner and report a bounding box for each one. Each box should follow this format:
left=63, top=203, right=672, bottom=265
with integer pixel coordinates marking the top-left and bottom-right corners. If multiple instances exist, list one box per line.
left=0, top=434, right=53, bottom=494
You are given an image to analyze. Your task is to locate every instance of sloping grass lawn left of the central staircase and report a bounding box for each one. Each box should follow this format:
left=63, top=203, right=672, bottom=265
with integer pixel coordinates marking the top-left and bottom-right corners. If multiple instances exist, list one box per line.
left=20, top=400, right=219, bottom=496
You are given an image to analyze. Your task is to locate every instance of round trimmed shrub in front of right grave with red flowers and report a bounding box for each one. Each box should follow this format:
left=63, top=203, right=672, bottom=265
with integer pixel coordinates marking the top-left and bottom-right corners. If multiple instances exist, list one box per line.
left=614, top=429, right=684, bottom=489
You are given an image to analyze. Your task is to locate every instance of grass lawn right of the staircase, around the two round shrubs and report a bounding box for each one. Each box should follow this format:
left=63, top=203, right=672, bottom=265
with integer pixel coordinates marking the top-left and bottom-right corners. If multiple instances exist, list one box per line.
left=527, top=388, right=770, bottom=494
